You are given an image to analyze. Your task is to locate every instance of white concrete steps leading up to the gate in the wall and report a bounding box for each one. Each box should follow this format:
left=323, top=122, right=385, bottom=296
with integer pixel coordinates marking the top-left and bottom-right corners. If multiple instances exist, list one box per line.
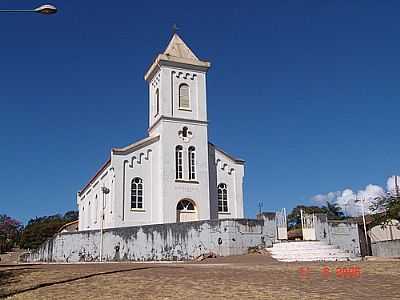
left=267, top=241, right=358, bottom=262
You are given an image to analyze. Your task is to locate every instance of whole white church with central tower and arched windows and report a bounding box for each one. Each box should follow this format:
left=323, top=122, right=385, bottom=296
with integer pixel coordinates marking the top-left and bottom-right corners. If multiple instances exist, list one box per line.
left=77, top=33, right=244, bottom=231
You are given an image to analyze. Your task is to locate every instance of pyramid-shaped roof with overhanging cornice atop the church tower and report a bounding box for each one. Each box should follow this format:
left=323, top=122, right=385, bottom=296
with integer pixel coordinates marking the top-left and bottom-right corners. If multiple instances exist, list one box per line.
left=144, top=33, right=211, bottom=80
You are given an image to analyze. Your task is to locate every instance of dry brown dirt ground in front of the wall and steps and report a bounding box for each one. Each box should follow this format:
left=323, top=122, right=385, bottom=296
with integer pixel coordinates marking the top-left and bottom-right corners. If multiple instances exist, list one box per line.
left=0, top=254, right=400, bottom=300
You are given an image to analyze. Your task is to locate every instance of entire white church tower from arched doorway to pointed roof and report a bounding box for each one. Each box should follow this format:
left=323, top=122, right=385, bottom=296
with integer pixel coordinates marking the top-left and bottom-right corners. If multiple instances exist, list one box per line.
left=144, top=33, right=214, bottom=223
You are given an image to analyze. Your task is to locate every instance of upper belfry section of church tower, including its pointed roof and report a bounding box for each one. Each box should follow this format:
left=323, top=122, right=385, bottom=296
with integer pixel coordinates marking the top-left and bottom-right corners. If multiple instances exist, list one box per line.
left=144, top=33, right=210, bottom=135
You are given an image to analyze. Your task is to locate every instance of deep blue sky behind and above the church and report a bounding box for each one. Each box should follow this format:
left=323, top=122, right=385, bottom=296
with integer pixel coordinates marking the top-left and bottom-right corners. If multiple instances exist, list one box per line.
left=0, top=0, right=400, bottom=222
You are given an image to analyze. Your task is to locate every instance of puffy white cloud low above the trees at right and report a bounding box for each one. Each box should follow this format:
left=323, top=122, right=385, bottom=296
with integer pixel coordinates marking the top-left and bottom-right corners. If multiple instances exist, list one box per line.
left=311, top=176, right=392, bottom=216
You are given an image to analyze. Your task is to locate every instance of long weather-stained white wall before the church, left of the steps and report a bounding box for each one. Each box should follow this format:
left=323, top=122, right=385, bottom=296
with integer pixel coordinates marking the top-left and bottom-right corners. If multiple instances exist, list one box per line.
left=27, top=219, right=271, bottom=262
